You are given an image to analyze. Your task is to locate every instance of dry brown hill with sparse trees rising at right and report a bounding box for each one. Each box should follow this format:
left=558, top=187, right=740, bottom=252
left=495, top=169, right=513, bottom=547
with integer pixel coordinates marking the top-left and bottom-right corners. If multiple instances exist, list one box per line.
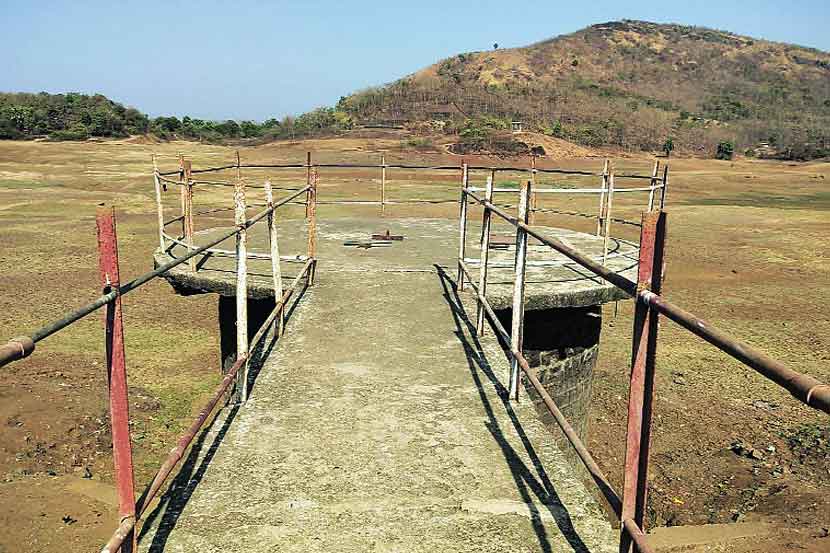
left=338, top=20, right=830, bottom=158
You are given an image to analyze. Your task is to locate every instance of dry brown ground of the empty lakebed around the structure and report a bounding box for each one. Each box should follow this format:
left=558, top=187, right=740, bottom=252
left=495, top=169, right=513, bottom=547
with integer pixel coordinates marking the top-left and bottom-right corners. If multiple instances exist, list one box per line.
left=0, top=137, right=830, bottom=552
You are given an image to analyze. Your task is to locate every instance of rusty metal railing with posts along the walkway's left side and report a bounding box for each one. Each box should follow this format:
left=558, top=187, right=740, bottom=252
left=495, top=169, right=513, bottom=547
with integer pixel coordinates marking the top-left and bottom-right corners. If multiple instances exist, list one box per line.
left=0, top=180, right=317, bottom=553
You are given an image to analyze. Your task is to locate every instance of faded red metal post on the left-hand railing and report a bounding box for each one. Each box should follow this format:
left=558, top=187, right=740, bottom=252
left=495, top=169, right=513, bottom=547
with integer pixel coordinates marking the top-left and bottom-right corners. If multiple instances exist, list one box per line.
left=96, top=207, right=136, bottom=553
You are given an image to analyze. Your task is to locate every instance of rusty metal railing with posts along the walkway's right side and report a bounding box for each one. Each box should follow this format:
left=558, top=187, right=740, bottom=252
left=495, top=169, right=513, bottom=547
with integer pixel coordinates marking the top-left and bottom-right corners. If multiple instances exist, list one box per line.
left=457, top=178, right=830, bottom=553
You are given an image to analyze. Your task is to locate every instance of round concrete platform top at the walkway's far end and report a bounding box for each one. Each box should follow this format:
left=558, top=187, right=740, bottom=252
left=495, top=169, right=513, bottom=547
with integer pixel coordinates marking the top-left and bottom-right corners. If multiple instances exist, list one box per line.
left=155, top=218, right=637, bottom=310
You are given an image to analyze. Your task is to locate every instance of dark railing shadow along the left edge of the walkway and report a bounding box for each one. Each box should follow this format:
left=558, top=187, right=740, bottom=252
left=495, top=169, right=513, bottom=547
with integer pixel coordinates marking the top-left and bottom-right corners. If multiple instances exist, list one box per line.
left=138, top=285, right=308, bottom=553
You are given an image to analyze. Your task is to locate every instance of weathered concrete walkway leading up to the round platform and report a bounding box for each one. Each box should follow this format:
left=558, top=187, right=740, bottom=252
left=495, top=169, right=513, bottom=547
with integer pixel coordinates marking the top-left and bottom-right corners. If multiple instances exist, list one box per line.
left=141, top=263, right=617, bottom=553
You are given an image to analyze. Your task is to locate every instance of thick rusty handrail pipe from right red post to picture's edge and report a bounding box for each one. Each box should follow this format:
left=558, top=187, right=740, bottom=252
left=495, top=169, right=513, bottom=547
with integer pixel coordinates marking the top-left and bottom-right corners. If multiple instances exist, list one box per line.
left=638, top=290, right=830, bottom=414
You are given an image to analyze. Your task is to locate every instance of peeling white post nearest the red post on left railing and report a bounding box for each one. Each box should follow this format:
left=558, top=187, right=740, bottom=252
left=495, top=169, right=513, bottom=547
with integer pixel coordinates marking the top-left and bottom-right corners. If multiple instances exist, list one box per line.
left=233, top=179, right=248, bottom=403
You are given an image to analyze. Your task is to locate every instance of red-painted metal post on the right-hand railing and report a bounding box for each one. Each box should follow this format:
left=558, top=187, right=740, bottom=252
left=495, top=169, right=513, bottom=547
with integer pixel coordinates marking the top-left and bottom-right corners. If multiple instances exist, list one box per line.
left=620, top=211, right=666, bottom=553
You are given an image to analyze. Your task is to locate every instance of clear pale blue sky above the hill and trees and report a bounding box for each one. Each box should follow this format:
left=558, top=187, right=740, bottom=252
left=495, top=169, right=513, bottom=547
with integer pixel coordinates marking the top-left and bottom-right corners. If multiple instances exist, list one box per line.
left=0, top=0, right=830, bottom=120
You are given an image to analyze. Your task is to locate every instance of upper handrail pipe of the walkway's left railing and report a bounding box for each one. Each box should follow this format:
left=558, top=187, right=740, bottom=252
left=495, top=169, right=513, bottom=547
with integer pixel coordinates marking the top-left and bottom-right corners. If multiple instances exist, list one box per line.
left=0, top=186, right=309, bottom=367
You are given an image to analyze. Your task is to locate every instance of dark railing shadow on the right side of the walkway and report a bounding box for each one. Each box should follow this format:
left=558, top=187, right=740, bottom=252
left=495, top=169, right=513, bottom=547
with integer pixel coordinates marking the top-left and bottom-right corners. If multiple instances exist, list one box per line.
left=436, top=265, right=589, bottom=553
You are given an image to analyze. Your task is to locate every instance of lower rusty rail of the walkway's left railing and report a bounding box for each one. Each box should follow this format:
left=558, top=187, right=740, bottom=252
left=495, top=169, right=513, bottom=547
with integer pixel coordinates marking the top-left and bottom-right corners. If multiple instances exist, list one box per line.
left=101, top=259, right=315, bottom=553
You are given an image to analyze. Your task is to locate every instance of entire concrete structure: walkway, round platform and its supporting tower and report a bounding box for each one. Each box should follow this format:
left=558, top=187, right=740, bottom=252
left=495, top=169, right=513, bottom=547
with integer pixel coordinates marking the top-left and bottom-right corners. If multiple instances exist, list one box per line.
left=142, top=218, right=636, bottom=553
